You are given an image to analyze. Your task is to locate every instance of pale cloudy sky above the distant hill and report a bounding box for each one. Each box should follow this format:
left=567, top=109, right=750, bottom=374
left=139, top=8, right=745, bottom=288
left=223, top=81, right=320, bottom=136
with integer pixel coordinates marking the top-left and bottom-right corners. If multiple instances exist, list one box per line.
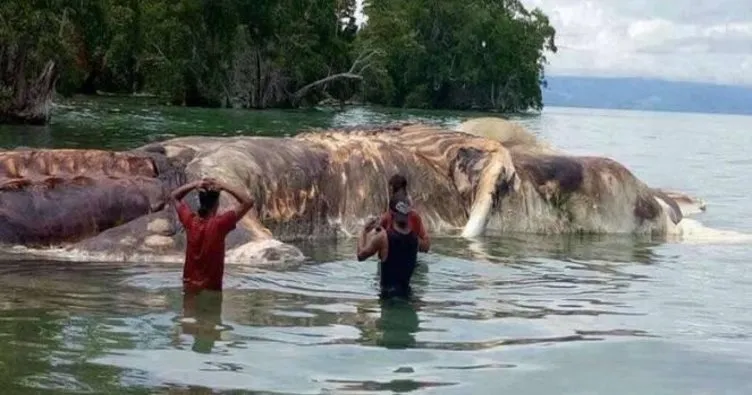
left=356, top=0, right=752, bottom=85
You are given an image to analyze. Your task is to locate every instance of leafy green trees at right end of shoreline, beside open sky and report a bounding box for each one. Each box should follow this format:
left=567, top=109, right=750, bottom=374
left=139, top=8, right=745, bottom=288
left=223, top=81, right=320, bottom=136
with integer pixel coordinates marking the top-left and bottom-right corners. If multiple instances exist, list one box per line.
left=359, top=0, right=556, bottom=111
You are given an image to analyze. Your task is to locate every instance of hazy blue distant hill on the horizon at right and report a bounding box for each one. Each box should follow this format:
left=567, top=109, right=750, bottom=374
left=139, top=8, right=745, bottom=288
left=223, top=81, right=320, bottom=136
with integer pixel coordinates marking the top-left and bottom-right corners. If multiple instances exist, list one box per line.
left=543, top=76, right=752, bottom=115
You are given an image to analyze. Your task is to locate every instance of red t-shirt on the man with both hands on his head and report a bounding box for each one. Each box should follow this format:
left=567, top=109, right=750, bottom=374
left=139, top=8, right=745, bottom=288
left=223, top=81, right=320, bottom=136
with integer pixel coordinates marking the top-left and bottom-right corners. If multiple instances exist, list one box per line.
left=177, top=202, right=237, bottom=291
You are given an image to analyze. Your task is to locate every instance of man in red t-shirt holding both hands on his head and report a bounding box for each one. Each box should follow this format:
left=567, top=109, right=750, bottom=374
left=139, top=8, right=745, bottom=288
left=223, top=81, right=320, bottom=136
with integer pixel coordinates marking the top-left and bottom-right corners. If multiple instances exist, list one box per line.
left=172, top=179, right=253, bottom=291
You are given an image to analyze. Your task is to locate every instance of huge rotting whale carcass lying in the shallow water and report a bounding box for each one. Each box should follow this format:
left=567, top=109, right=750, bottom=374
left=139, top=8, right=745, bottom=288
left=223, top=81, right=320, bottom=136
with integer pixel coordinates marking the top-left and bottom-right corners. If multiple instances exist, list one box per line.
left=0, top=119, right=704, bottom=262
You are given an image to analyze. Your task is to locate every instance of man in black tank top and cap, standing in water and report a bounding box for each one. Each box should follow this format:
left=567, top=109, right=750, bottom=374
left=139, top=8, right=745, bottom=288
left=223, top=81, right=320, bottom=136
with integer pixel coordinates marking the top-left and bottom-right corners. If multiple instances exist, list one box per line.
left=357, top=195, right=418, bottom=298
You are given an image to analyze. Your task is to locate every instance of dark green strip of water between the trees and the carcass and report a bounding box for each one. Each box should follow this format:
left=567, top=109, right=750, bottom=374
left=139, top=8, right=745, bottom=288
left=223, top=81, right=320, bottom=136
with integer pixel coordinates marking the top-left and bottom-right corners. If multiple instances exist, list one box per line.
left=0, top=97, right=488, bottom=149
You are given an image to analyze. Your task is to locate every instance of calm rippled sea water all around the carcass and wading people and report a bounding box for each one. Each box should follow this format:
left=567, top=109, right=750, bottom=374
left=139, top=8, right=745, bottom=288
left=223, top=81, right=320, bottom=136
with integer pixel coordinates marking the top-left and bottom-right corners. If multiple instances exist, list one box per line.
left=0, top=101, right=752, bottom=394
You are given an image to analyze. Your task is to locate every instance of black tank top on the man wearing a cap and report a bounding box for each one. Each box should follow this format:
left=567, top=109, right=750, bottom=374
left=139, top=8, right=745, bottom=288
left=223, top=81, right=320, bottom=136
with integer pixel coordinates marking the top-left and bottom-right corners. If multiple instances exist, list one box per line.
left=379, top=229, right=418, bottom=298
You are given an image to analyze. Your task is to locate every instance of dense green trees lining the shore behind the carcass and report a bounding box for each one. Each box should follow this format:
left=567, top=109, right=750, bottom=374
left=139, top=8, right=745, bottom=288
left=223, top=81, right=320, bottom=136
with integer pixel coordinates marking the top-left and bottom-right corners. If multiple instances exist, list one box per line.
left=0, top=0, right=556, bottom=123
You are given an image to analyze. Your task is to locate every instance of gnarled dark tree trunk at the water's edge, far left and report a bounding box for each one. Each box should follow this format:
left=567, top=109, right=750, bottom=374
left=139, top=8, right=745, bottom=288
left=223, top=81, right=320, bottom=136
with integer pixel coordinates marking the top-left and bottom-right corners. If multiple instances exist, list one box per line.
left=0, top=55, right=59, bottom=125
